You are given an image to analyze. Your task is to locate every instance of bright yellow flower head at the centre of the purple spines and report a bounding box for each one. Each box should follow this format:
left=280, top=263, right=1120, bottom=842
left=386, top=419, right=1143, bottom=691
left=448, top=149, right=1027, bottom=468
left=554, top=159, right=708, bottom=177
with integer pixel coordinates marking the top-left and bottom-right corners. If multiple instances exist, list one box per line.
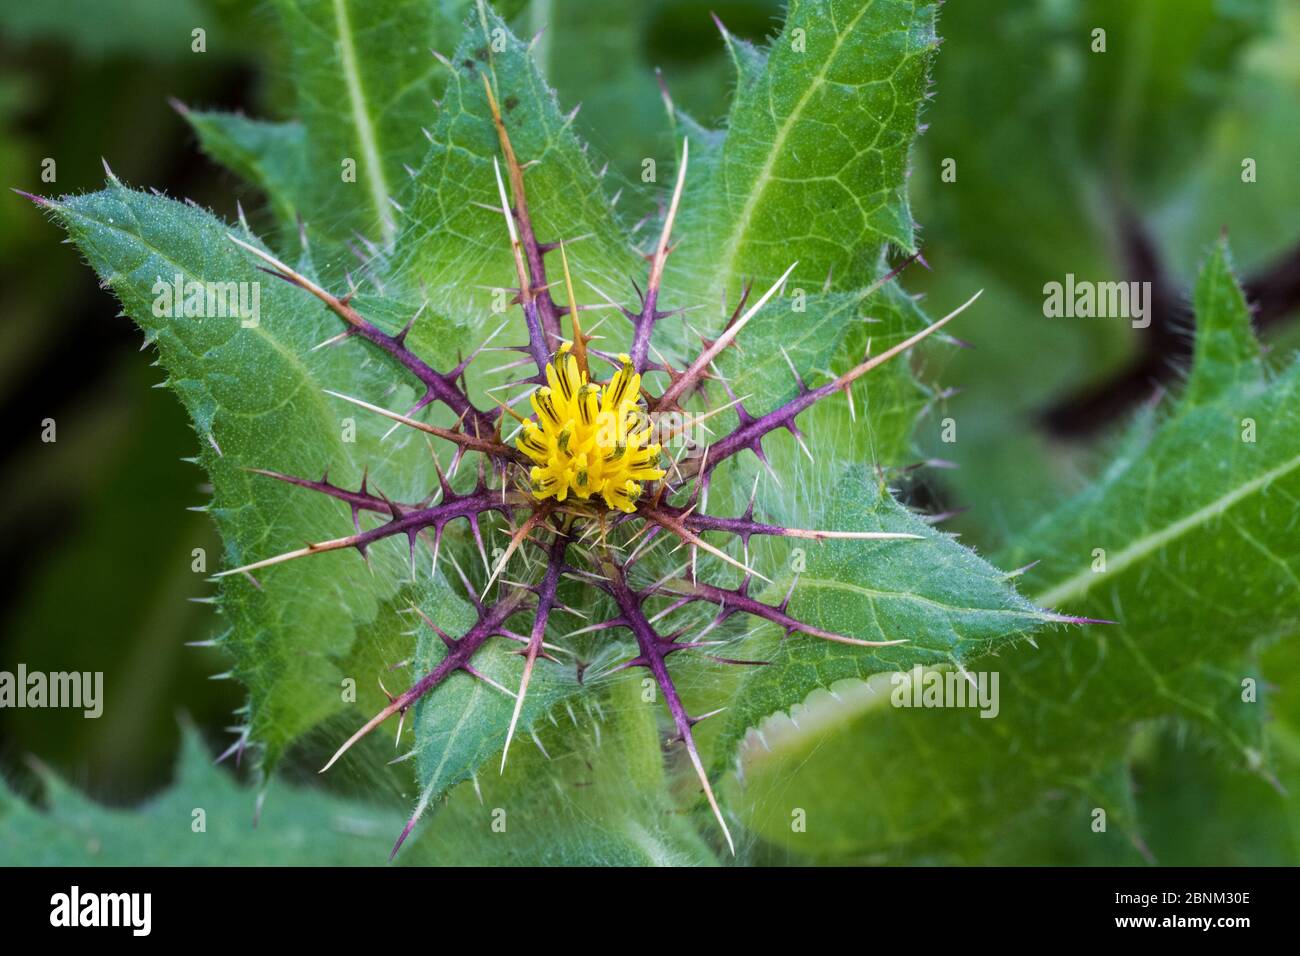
left=515, top=345, right=664, bottom=512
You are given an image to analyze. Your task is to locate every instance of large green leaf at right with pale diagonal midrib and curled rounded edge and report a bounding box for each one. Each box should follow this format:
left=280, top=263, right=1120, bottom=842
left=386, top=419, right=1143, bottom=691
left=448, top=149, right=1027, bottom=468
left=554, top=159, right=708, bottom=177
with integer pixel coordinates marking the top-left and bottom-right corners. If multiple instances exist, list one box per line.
left=748, top=243, right=1300, bottom=862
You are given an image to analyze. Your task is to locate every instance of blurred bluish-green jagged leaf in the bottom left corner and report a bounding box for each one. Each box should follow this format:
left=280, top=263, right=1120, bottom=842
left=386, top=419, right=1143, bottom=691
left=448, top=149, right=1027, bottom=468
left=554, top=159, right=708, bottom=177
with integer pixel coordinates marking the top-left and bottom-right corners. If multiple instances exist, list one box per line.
left=0, top=730, right=402, bottom=866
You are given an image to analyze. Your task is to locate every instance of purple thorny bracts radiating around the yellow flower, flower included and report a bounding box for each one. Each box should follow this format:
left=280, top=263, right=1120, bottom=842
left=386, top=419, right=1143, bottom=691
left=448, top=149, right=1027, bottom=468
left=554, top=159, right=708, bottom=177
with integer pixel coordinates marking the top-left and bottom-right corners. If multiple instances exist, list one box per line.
left=222, top=77, right=974, bottom=852
